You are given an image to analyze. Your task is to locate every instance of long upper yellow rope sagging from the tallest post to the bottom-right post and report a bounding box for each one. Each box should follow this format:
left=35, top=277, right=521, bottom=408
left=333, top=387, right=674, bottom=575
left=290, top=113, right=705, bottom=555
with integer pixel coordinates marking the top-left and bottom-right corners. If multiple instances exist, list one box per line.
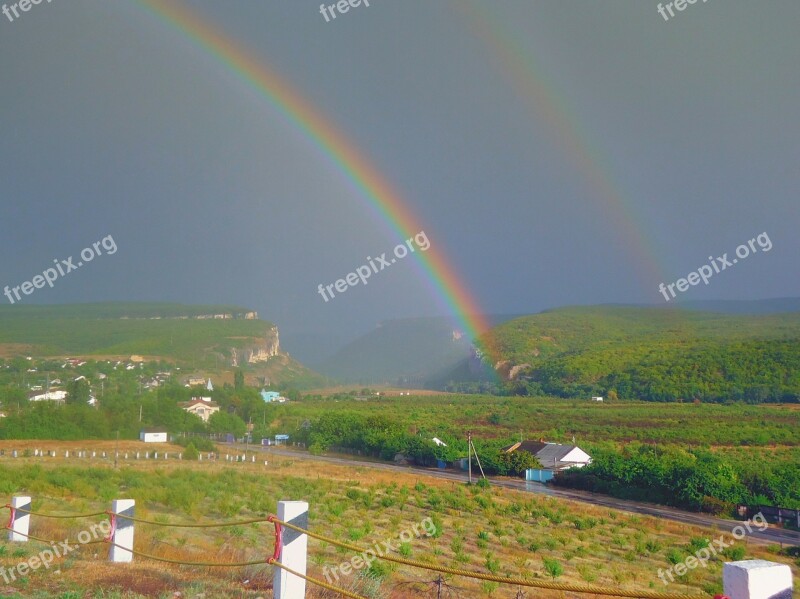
left=276, top=520, right=708, bottom=599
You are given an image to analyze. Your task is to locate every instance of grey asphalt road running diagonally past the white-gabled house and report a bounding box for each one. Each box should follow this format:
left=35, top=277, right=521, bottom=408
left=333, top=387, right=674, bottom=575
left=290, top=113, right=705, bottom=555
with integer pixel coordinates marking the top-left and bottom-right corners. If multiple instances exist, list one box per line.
left=242, top=445, right=800, bottom=546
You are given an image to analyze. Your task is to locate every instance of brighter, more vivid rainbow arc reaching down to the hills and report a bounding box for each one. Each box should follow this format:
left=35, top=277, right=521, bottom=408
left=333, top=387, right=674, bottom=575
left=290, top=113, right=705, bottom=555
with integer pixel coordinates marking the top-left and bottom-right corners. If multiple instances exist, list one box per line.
left=137, top=0, right=489, bottom=339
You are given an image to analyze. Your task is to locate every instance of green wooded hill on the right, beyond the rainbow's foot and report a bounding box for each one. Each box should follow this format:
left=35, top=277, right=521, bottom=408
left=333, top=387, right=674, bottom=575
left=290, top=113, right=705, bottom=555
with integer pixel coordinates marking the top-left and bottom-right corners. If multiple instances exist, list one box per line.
left=480, top=306, right=800, bottom=403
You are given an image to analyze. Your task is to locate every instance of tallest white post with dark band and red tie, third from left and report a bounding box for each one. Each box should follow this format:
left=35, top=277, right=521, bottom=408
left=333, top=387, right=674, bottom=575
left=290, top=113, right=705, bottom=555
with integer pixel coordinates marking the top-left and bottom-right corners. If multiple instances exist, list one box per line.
left=273, top=501, right=308, bottom=599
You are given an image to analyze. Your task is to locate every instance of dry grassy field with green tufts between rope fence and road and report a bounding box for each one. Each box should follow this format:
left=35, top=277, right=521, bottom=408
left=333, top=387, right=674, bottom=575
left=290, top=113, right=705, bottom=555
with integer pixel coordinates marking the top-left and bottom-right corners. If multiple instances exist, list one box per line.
left=0, top=441, right=800, bottom=599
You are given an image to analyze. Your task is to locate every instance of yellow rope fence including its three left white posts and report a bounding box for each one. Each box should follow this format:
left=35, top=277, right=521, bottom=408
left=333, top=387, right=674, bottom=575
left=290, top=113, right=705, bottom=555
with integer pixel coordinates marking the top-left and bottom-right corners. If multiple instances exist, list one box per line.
left=0, top=496, right=768, bottom=599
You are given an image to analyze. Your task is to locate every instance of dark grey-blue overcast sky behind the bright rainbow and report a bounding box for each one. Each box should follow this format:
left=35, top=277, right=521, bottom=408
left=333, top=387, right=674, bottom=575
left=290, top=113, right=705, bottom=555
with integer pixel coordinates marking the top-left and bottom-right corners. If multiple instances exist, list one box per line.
left=0, top=0, right=800, bottom=359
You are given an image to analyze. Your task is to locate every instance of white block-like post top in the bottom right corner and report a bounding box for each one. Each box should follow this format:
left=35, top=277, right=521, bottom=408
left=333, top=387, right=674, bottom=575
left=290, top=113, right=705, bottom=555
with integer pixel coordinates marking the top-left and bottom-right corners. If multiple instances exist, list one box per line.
left=722, top=559, right=793, bottom=599
